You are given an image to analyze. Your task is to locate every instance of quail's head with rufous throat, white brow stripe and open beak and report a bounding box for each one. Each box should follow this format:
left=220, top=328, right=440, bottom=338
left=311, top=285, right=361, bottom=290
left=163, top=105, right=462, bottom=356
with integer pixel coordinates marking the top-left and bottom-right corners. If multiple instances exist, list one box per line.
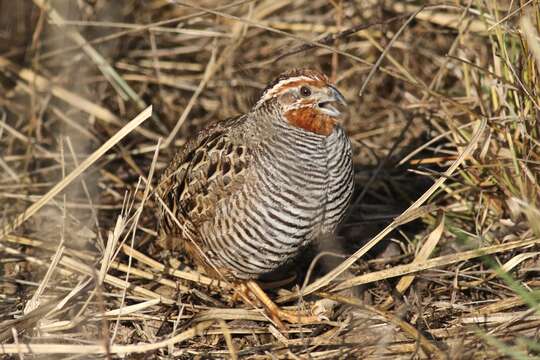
left=255, top=69, right=346, bottom=135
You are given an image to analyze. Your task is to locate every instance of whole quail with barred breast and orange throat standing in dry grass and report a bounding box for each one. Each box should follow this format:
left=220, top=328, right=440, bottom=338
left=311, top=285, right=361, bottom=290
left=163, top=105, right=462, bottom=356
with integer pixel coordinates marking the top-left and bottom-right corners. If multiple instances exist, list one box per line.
left=157, top=68, right=354, bottom=326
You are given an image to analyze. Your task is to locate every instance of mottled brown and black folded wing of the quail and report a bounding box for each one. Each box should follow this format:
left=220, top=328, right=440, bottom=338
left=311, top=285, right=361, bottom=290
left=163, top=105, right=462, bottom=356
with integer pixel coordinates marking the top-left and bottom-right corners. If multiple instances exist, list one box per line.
left=158, top=116, right=251, bottom=237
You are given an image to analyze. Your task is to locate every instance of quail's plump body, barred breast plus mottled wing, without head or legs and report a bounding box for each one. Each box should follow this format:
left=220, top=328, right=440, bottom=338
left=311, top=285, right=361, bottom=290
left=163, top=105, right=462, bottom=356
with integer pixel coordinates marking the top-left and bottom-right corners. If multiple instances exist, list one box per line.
left=158, top=69, right=353, bottom=279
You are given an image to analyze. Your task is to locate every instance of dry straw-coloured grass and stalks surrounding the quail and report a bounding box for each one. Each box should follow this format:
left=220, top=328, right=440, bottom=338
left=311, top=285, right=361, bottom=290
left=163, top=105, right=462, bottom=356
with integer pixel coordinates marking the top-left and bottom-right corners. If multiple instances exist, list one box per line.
left=0, top=0, right=540, bottom=359
